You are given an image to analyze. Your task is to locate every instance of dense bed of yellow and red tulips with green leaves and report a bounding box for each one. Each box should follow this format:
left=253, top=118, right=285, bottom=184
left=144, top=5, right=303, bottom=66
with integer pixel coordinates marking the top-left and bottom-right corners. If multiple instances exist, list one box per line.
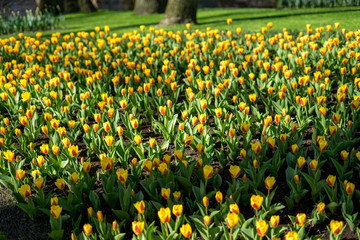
left=0, top=19, right=360, bottom=240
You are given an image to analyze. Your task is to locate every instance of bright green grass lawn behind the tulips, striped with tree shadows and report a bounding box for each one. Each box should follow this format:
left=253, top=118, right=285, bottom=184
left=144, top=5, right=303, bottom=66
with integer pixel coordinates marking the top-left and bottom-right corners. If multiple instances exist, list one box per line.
left=0, top=7, right=360, bottom=37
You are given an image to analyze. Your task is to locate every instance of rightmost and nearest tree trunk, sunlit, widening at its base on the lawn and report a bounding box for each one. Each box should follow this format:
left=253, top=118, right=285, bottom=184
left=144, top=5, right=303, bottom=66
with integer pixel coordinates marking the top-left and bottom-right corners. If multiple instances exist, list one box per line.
left=160, top=0, right=198, bottom=26
